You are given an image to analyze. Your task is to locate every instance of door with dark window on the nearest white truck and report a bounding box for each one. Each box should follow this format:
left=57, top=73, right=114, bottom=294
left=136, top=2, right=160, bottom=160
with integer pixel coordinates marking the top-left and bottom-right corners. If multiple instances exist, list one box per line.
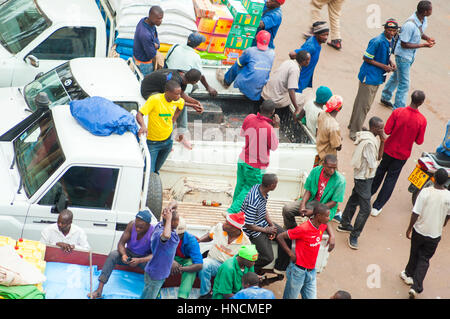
left=23, top=166, right=120, bottom=254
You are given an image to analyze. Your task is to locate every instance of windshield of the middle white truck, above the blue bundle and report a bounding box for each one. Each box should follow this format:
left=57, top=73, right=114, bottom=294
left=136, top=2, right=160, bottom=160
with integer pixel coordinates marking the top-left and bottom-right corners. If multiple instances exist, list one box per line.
left=24, top=62, right=88, bottom=112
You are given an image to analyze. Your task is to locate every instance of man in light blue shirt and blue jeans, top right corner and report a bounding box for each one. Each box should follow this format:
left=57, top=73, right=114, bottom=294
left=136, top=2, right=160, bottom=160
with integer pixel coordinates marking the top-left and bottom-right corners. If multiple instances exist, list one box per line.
left=380, top=1, right=436, bottom=109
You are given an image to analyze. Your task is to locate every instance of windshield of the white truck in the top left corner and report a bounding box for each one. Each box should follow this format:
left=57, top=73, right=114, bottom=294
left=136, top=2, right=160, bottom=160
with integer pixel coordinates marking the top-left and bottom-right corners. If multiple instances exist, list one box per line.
left=0, top=0, right=51, bottom=54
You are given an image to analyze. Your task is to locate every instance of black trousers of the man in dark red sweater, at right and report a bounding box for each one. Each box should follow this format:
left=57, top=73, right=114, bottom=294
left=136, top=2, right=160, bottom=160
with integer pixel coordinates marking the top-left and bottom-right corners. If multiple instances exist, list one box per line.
left=372, top=153, right=406, bottom=209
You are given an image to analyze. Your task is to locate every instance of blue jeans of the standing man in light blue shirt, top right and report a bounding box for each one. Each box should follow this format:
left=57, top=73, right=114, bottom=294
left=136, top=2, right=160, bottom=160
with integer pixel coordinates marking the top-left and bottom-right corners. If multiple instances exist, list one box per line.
left=381, top=55, right=414, bottom=109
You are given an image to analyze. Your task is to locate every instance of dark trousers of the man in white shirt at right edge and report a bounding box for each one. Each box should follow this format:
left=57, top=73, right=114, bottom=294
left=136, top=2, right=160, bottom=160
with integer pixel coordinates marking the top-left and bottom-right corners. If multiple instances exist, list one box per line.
left=405, top=228, right=441, bottom=293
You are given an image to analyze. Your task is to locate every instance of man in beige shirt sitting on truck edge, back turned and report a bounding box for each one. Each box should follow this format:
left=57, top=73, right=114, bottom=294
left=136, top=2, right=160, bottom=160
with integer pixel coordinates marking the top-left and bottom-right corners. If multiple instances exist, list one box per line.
left=261, top=51, right=311, bottom=121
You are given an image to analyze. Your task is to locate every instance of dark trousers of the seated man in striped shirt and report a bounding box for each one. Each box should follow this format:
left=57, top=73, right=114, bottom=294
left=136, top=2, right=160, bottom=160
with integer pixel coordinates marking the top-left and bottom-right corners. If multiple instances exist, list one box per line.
left=250, top=224, right=289, bottom=272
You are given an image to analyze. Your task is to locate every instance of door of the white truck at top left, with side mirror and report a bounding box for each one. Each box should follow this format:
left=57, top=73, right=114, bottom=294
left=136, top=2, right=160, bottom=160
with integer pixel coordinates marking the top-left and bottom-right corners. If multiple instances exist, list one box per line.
left=12, top=27, right=97, bottom=86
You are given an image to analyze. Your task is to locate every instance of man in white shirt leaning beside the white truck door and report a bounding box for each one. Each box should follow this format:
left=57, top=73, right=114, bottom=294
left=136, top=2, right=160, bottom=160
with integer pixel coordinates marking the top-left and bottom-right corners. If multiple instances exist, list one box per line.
left=40, top=209, right=90, bottom=252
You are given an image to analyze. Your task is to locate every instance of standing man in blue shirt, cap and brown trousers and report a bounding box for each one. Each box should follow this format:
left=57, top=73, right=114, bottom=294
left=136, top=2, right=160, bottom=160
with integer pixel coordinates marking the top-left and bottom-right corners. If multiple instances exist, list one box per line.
left=348, top=19, right=398, bottom=141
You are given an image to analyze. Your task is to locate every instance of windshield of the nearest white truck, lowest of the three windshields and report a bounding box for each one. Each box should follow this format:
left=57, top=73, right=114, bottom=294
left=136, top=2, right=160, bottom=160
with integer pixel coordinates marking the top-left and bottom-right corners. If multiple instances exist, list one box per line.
left=14, top=112, right=65, bottom=198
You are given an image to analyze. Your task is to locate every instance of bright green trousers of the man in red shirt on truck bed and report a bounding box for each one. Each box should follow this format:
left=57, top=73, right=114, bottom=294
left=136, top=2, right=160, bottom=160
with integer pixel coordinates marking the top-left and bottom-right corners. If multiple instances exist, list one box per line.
left=227, top=159, right=266, bottom=214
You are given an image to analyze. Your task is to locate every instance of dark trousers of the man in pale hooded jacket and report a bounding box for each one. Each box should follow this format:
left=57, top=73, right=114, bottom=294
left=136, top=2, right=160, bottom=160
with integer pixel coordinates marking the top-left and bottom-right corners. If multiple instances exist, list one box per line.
left=341, top=178, right=373, bottom=238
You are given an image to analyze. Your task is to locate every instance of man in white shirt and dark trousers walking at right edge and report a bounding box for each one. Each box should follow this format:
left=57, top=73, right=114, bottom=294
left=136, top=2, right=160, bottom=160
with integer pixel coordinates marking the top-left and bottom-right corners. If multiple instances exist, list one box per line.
left=400, top=168, right=450, bottom=299
